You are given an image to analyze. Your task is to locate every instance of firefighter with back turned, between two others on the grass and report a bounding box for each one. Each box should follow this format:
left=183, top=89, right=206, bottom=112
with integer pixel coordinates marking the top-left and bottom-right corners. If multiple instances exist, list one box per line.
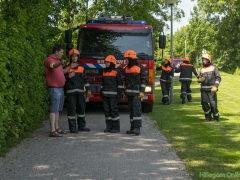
left=175, top=56, right=198, bottom=104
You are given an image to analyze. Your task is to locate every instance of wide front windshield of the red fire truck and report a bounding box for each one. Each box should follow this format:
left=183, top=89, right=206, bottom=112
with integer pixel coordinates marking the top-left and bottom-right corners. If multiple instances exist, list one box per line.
left=78, top=29, right=153, bottom=56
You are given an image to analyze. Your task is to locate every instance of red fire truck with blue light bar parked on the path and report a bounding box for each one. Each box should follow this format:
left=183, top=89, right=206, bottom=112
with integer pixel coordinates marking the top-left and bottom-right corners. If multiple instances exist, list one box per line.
left=65, top=15, right=155, bottom=112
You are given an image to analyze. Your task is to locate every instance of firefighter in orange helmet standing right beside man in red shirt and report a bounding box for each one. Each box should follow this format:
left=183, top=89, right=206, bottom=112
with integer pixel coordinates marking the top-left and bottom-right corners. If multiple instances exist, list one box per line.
left=65, top=48, right=91, bottom=133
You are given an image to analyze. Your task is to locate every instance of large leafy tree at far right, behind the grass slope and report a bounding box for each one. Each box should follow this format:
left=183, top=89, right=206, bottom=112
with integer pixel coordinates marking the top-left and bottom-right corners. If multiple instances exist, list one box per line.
left=198, top=0, right=240, bottom=72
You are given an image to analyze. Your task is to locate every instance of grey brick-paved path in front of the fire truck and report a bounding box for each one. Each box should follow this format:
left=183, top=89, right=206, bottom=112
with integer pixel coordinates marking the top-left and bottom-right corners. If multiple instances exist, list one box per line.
left=0, top=76, right=191, bottom=180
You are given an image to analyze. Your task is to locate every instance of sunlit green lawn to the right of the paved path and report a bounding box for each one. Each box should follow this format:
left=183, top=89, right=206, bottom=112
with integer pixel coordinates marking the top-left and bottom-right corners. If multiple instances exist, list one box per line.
left=149, top=72, right=240, bottom=180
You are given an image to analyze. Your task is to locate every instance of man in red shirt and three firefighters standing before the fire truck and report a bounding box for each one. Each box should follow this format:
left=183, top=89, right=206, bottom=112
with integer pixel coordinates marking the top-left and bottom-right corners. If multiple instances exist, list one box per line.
left=44, top=45, right=147, bottom=137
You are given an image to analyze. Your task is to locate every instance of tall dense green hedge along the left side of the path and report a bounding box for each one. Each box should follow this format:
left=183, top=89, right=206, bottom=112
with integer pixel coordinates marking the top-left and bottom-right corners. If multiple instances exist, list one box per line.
left=0, top=0, right=69, bottom=146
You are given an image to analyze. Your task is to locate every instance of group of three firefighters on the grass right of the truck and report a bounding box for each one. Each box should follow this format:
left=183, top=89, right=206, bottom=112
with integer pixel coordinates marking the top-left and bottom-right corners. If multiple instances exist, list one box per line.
left=156, top=54, right=221, bottom=122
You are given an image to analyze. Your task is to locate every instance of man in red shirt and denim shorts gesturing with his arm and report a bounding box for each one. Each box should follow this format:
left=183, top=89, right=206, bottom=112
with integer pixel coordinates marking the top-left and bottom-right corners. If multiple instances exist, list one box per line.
left=44, top=45, right=77, bottom=137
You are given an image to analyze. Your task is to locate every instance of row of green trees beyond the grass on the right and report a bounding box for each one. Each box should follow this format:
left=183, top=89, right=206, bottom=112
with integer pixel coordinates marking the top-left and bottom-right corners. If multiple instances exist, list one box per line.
left=174, top=0, right=240, bottom=73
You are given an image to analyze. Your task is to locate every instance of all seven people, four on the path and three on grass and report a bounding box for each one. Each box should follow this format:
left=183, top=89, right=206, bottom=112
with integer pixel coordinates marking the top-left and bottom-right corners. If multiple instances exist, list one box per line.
left=44, top=45, right=221, bottom=137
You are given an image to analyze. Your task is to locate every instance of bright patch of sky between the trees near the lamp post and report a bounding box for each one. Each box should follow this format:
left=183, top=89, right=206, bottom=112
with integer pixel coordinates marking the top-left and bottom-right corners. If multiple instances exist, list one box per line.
left=169, top=0, right=197, bottom=33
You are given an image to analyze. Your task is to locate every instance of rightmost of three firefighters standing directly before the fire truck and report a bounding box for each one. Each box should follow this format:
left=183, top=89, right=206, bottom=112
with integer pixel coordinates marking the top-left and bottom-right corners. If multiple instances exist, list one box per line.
left=124, top=50, right=147, bottom=135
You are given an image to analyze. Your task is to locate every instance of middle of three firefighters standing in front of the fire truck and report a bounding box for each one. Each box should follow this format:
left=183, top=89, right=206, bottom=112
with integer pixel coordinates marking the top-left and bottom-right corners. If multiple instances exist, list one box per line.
left=100, top=55, right=123, bottom=133
